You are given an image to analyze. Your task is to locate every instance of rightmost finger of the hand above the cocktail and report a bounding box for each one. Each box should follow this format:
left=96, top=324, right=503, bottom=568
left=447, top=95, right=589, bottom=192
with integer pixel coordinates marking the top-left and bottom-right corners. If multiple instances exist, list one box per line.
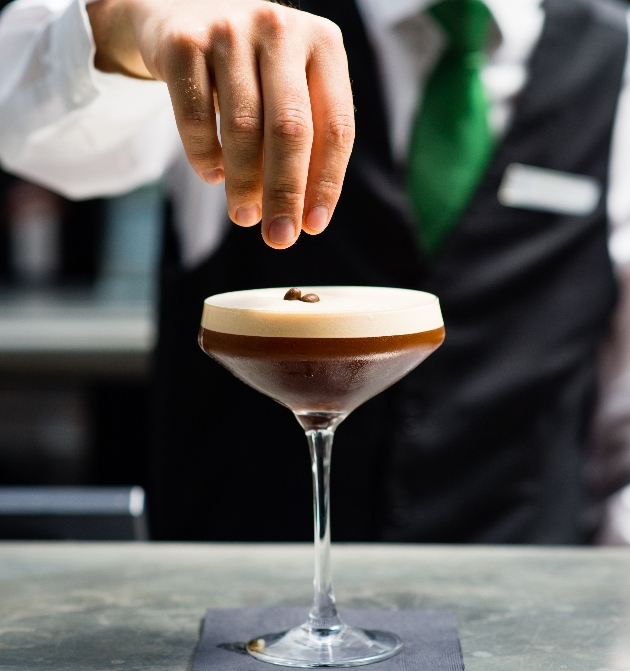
left=302, top=24, right=354, bottom=235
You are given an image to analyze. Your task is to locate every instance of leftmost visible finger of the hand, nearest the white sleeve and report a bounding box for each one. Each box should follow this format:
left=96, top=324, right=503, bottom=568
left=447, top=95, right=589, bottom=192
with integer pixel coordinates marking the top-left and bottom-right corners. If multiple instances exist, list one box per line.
left=162, top=40, right=224, bottom=184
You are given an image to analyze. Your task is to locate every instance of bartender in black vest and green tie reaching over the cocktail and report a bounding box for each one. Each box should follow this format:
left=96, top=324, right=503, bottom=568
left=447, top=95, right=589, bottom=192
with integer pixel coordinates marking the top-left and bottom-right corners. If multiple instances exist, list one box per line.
left=0, top=0, right=630, bottom=543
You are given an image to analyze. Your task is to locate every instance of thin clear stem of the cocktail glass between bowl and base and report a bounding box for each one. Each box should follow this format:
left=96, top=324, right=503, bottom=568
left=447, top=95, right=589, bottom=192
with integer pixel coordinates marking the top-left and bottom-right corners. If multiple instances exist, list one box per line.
left=306, top=425, right=344, bottom=636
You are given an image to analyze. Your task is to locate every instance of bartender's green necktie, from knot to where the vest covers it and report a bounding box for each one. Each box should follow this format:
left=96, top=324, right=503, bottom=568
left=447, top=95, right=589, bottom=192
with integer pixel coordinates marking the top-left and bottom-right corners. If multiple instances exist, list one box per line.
left=407, top=0, right=494, bottom=255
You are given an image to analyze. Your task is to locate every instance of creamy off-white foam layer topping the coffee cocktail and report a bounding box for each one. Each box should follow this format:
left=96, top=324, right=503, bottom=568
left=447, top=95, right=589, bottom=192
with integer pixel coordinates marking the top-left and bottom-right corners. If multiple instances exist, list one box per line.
left=201, top=287, right=444, bottom=338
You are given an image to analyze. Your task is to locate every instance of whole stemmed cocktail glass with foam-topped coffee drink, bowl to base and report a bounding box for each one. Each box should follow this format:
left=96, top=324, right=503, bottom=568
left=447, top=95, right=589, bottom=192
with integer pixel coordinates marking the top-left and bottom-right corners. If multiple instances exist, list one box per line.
left=199, top=287, right=444, bottom=667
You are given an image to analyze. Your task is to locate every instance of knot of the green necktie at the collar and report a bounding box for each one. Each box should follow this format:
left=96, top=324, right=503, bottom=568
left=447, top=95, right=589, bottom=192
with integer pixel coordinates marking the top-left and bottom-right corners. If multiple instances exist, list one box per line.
left=429, top=0, right=492, bottom=53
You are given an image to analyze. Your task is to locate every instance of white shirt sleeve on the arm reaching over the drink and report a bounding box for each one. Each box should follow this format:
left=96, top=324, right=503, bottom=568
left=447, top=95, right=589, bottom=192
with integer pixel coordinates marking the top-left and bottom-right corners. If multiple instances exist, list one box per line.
left=0, top=0, right=181, bottom=198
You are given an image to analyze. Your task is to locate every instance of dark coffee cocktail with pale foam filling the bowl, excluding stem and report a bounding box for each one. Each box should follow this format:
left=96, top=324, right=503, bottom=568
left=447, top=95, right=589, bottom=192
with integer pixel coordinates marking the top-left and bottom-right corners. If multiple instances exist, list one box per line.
left=199, top=287, right=444, bottom=426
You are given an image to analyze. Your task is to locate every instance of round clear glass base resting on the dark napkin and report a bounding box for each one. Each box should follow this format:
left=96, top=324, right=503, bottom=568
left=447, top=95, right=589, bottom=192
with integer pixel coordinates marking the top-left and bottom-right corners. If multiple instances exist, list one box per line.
left=246, top=624, right=402, bottom=668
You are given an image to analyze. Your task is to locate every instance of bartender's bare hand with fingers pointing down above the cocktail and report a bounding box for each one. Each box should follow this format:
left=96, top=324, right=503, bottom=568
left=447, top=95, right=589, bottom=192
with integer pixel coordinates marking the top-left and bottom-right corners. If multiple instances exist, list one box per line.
left=88, top=0, right=354, bottom=249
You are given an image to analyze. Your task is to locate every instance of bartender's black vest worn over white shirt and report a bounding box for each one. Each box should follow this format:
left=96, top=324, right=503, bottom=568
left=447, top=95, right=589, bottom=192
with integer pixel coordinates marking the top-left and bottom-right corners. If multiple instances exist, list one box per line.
left=154, top=0, right=627, bottom=543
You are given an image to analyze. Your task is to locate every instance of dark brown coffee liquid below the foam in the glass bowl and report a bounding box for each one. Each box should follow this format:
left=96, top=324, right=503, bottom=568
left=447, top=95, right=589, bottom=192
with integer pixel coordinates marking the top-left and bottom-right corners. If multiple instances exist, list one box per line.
left=199, top=326, right=444, bottom=415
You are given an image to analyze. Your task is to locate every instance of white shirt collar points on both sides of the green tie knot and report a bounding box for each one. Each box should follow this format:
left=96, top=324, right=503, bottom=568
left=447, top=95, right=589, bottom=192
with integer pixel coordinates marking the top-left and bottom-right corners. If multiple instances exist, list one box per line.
left=358, top=0, right=542, bottom=44
